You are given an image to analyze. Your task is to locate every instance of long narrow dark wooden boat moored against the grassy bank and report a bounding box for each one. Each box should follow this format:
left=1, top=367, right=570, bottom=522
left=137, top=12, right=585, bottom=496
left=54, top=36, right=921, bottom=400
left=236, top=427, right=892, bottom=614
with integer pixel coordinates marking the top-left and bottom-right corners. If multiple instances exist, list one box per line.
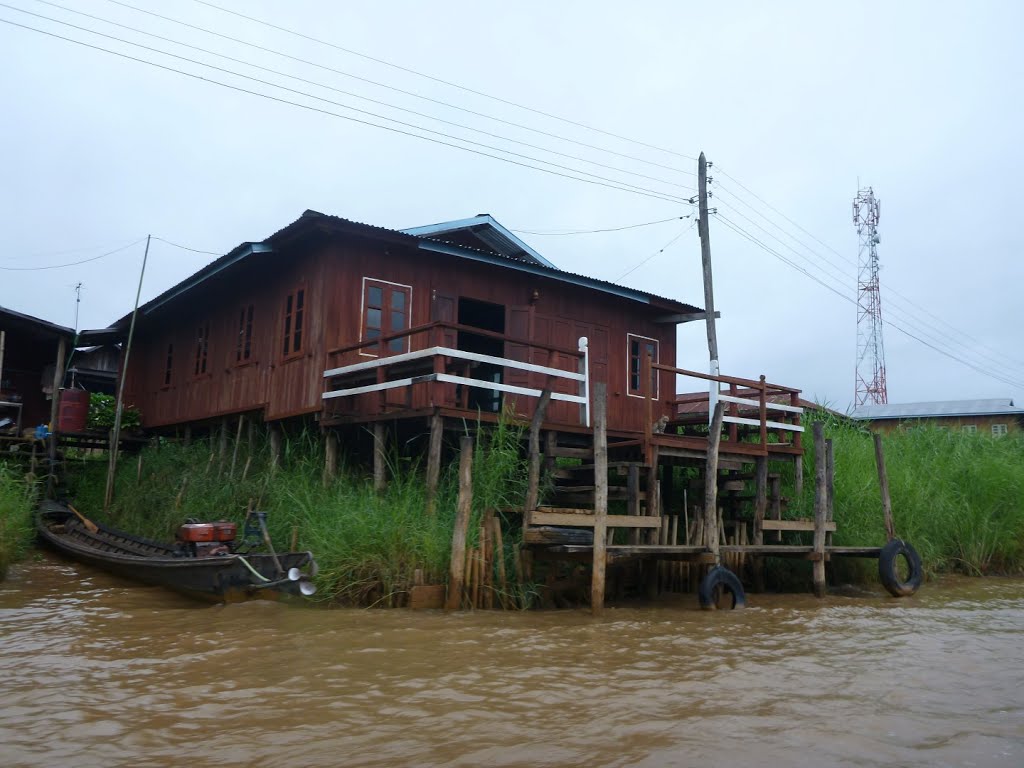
left=36, top=501, right=316, bottom=602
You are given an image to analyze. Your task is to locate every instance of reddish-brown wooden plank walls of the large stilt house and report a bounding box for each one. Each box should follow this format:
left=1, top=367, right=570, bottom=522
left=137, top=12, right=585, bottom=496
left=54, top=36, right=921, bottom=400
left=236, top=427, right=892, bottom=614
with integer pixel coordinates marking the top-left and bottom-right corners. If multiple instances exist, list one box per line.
left=127, top=224, right=688, bottom=438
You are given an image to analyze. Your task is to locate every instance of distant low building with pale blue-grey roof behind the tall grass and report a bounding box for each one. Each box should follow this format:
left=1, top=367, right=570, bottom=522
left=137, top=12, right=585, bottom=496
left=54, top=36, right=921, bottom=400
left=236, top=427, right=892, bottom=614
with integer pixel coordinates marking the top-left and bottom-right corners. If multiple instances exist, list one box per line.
left=850, top=399, right=1024, bottom=436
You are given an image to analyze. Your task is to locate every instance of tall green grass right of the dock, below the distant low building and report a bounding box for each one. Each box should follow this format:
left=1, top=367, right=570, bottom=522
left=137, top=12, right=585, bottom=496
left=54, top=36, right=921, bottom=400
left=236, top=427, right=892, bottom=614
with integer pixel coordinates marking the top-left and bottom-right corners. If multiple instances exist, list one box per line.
left=795, top=418, right=1024, bottom=574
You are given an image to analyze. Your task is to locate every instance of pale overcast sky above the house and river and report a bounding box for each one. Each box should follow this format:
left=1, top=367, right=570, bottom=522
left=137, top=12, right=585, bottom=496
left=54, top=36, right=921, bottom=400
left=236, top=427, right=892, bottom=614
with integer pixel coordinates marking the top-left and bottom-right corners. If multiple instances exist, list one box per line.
left=0, top=0, right=1024, bottom=410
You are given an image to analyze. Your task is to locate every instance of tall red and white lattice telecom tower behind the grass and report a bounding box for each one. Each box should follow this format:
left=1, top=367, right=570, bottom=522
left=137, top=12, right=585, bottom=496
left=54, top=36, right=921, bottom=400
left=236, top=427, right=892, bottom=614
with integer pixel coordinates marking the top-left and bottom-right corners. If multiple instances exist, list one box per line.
left=853, top=186, right=889, bottom=408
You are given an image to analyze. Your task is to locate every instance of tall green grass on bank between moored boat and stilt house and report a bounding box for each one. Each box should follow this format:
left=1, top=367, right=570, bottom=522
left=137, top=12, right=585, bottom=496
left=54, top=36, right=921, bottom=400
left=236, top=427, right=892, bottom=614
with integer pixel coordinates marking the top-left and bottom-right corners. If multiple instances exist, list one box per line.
left=69, top=424, right=529, bottom=605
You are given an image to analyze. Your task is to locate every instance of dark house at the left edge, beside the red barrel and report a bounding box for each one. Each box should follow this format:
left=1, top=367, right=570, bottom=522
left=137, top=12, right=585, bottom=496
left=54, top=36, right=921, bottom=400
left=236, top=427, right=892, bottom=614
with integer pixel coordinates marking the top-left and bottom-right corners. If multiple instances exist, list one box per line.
left=0, top=307, right=75, bottom=432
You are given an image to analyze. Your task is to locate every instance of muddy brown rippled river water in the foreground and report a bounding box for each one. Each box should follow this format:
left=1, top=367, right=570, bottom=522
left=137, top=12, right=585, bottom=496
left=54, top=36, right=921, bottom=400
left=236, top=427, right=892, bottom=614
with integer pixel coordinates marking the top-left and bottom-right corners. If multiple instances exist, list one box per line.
left=0, top=555, right=1024, bottom=768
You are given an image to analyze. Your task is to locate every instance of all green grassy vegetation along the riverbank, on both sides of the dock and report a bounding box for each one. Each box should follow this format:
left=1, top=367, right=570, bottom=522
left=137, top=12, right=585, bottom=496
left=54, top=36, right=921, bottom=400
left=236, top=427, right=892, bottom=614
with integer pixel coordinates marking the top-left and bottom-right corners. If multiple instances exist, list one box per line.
left=0, top=415, right=1024, bottom=607
